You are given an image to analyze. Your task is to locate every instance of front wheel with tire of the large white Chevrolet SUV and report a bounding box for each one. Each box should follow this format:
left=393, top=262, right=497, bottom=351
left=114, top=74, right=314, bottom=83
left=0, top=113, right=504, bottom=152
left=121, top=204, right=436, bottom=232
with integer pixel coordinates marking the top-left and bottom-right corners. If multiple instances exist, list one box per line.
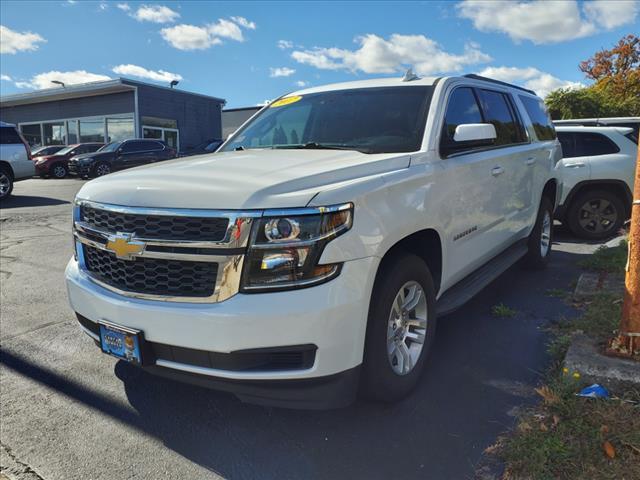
left=361, top=254, right=436, bottom=402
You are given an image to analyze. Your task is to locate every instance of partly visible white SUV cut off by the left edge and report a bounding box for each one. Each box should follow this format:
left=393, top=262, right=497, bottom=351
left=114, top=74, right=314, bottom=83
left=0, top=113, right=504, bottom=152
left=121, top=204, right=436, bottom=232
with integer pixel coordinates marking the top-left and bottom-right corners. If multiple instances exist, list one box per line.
left=0, top=122, right=36, bottom=200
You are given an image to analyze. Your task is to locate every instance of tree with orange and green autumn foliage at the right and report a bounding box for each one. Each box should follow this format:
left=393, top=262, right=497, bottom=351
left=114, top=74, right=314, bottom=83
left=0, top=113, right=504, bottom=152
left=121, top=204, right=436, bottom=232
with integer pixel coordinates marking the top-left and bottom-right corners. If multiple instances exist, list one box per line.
left=545, top=35, right=640, bottom=120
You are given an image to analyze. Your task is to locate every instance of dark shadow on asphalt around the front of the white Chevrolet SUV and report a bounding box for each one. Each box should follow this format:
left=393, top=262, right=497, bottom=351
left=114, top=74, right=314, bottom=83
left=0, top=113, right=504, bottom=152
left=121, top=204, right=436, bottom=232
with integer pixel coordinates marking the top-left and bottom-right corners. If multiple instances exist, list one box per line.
left=2, top=248, right=579, bottom=480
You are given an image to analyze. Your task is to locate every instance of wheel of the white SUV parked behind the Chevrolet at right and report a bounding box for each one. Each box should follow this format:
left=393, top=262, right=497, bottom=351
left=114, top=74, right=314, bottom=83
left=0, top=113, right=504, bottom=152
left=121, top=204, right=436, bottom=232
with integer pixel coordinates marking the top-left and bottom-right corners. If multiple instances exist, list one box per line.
left=566, top=190, right=625, bottom=240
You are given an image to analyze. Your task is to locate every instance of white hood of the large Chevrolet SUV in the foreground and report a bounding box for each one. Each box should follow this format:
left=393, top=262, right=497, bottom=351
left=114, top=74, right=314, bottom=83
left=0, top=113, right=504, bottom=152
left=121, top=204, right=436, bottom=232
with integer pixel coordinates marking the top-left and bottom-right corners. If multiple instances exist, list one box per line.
left=78, top=150, right=410, bottom=209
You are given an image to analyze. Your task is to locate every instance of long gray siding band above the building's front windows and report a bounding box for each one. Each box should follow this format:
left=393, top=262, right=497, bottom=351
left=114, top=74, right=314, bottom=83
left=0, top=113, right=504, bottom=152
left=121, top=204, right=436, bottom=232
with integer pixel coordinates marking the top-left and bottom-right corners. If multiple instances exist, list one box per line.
left=0, top=92, right=135, bottom=124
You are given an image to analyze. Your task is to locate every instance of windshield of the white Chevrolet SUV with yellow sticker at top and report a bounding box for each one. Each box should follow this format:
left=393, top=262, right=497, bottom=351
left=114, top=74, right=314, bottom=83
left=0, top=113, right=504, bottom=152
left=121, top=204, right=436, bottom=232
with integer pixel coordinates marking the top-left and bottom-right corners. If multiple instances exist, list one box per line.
left=222, top=86, right=433, bottom=153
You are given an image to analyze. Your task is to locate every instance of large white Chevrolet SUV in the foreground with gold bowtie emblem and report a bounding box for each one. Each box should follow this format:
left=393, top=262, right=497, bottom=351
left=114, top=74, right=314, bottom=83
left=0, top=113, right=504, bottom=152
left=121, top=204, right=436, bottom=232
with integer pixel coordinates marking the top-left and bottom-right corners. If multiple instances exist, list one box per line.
left=66, top=75, right=561, bottom=408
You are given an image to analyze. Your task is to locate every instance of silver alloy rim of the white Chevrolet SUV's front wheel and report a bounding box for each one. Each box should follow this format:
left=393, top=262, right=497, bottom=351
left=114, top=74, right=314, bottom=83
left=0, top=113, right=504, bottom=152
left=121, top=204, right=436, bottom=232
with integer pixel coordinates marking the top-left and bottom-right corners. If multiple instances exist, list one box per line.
left=387, top=281, right=428, bottom=375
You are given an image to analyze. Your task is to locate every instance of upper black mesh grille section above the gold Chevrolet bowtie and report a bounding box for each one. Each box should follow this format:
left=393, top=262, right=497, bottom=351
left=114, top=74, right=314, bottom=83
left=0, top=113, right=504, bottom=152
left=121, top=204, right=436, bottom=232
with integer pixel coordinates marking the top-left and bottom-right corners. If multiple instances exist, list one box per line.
left=80, top=205, right=229, bottom=242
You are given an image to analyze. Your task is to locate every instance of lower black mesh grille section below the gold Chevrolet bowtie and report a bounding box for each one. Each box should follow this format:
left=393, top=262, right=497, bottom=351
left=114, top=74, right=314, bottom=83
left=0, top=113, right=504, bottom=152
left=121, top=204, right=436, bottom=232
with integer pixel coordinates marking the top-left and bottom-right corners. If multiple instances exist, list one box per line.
left=84, top=245, right=218, bottom=297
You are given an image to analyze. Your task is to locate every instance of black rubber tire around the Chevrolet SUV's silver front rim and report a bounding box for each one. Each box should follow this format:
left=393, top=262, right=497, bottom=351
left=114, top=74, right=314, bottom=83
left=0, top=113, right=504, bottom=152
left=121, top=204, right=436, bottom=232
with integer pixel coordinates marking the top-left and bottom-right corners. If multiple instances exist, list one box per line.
left=361, top=253, right=436, bottom=402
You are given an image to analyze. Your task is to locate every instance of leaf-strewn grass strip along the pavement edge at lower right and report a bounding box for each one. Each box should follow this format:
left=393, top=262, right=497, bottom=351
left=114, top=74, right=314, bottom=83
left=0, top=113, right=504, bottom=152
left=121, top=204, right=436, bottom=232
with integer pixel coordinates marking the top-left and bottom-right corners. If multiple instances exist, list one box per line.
left=496, top=242, right=640, bottom=480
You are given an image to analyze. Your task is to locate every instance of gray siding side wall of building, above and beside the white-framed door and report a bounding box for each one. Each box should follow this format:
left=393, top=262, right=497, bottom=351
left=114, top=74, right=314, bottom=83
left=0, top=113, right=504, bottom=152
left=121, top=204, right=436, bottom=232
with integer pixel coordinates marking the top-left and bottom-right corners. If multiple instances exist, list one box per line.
left=138, top=85, right=222, bottom=151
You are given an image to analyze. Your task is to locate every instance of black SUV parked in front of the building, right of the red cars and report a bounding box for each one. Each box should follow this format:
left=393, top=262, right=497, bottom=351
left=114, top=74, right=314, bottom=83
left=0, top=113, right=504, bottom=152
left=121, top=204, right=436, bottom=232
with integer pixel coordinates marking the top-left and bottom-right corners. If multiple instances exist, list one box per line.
left=69, top=140, right=176, bottom=177
